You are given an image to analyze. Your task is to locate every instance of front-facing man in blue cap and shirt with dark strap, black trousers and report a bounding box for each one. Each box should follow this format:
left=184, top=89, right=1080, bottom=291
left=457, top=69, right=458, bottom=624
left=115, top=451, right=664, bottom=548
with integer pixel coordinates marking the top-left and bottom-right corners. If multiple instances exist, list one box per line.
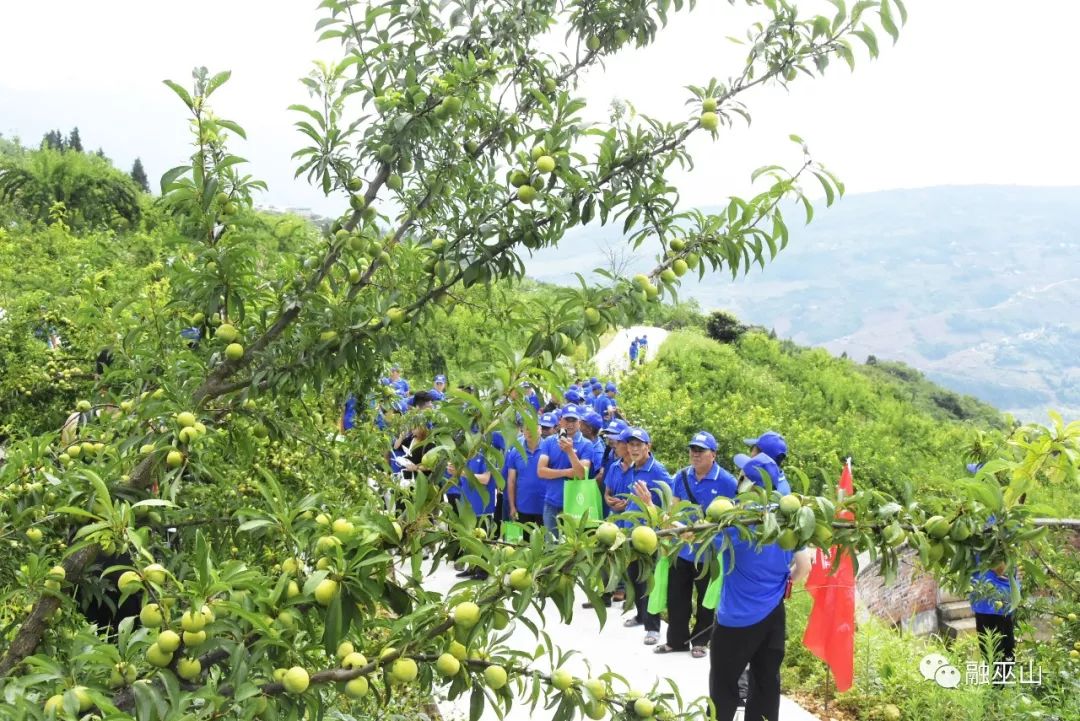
left=643, top=431, right=739, bottom=658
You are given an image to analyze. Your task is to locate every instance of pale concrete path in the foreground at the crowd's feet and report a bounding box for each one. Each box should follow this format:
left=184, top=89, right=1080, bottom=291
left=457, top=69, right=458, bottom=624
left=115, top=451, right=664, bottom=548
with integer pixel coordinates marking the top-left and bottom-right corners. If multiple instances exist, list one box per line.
left=424, top=561, right=819, bottom=721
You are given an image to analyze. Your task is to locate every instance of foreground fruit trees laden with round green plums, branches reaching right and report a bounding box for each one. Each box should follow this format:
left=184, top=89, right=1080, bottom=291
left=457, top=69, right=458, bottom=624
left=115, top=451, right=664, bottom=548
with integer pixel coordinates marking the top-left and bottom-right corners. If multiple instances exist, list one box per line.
left=0, top=0, right=1080, bottom=721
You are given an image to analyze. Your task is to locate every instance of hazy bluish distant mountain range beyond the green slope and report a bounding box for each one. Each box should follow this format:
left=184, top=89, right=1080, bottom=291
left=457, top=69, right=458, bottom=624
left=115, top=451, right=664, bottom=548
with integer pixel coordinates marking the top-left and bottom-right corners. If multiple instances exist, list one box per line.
left=528, top=186, right=1080, bottom=422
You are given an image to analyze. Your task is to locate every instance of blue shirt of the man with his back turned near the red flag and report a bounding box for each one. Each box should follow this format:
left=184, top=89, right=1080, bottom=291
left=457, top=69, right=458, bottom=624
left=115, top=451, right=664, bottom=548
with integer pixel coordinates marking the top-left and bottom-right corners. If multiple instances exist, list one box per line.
left=714, top=478, right=795, bottom=628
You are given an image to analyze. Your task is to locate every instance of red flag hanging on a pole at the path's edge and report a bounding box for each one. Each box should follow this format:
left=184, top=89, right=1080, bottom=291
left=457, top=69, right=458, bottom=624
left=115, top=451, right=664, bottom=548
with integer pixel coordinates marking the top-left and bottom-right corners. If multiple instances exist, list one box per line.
left=802, top=461, right=855, bottom=691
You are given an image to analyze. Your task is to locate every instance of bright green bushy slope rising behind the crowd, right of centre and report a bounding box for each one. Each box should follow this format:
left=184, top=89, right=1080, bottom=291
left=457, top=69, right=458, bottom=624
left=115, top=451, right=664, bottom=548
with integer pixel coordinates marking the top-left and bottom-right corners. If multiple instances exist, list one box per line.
left=620, top=330, right=1000, bottom=494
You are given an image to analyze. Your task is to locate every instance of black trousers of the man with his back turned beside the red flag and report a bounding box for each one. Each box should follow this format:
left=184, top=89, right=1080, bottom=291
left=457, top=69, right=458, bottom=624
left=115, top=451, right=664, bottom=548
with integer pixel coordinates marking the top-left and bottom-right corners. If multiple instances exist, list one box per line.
left=708, top=601, right=786, bottom=721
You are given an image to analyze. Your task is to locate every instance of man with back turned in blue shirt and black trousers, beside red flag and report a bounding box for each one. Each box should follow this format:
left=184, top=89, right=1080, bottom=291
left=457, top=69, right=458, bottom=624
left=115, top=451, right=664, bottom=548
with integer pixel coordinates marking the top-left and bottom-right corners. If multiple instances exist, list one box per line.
left=708, top=452, right=810, bottom=721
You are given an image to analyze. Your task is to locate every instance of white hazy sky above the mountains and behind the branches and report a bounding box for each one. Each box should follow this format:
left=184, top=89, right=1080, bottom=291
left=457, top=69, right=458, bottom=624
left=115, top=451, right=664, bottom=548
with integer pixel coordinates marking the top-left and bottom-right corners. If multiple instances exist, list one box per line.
left=0, top=0, right=1080, bottom=214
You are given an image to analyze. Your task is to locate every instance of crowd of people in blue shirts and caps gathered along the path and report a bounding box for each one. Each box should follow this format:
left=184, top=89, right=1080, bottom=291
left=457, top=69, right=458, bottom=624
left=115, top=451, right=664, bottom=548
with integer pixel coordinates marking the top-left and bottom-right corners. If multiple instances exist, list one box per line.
left=341, top=366, right=810, bottom=720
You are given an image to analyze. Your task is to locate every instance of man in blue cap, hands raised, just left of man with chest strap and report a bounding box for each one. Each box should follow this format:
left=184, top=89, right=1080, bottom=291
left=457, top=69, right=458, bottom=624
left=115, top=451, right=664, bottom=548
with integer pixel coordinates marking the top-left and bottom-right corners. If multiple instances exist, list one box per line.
left=616, top=428, right=672, bottom=645
